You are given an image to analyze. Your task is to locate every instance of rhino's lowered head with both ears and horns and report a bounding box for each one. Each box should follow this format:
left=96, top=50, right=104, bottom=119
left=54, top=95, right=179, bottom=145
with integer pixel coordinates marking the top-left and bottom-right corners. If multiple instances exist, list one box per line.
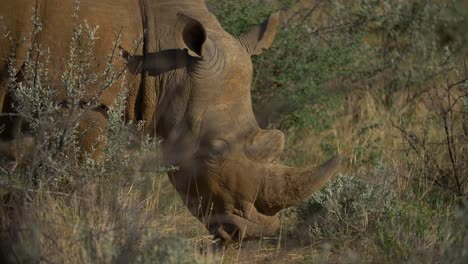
left=128, top=12, right=339, bottom=240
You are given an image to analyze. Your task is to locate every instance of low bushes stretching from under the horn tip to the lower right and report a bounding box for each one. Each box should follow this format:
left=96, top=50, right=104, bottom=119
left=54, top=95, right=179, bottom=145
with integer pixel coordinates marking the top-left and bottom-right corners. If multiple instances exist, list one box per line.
left=283, top=167, right=452, bottom=263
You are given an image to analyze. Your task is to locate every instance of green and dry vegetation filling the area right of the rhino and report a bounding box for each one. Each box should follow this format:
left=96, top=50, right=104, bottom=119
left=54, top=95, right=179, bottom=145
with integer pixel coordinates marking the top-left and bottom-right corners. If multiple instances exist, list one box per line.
left=212, top=0, right=468, bottom=263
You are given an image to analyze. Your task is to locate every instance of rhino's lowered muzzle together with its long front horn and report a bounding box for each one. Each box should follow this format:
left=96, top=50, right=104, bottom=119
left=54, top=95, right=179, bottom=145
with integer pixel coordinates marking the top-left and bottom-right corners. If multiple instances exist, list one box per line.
left=168, top=152, right=340, bottom=242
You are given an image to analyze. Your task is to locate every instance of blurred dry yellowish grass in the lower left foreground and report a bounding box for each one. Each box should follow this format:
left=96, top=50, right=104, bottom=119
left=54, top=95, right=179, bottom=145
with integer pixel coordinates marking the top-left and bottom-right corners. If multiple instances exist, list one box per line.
left=1, top=158, right=218, bottom=263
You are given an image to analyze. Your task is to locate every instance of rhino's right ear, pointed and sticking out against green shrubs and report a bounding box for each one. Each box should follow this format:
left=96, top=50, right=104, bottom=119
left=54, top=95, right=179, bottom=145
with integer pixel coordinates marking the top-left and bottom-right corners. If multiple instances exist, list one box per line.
left=240, top=12, right=280, bottom=55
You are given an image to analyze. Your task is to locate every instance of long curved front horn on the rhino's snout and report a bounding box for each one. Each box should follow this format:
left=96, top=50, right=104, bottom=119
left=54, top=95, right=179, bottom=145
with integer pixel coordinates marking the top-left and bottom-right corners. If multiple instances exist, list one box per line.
left=255, top=156, right=341, bottom=215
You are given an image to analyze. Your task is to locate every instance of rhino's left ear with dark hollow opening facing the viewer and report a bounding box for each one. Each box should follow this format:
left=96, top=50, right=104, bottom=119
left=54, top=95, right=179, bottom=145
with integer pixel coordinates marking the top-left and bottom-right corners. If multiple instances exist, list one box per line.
left=174, top=13, right=207, bottom=58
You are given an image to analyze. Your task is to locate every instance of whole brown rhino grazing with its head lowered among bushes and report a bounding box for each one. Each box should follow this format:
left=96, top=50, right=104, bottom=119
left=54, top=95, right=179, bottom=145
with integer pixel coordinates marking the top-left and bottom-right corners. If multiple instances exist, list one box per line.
left=0, top=0, right=340, bottom=241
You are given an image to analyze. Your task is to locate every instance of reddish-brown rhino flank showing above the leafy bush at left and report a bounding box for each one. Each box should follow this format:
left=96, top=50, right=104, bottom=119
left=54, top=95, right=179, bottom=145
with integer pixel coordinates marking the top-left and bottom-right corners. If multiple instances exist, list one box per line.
left=0, top=0, right=143, bottom=108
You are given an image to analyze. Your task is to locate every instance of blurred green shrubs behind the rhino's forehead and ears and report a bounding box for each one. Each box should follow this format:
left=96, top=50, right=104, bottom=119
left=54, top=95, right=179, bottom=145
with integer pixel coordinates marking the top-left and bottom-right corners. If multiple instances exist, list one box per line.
left=209, top=0, right=468, bottom=132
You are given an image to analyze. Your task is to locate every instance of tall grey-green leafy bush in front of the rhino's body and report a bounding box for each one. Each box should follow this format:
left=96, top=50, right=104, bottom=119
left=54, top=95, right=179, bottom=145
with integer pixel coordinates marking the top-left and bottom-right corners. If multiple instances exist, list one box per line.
left=2, top=3, right=138, bottom=191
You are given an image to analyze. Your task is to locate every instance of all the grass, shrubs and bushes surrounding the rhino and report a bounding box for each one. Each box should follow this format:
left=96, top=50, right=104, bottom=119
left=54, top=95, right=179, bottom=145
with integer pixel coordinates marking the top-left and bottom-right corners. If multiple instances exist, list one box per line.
left=0, top=0, right=468, bottom=263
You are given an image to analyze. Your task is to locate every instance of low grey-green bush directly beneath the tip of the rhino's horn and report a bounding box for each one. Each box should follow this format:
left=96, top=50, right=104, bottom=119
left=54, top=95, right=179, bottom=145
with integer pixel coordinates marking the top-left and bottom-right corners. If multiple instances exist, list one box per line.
left=296, top=167, right=396, bottom=240
